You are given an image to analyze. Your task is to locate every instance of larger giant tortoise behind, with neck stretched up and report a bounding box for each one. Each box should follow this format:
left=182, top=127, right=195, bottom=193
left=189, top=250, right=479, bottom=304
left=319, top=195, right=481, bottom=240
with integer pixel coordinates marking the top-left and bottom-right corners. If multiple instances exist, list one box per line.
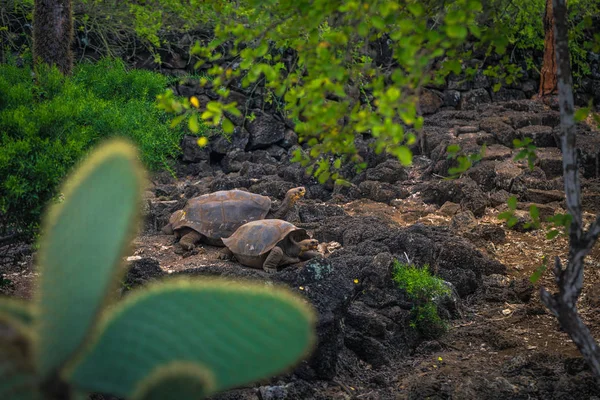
left=162, top=187, right=306, bottom=250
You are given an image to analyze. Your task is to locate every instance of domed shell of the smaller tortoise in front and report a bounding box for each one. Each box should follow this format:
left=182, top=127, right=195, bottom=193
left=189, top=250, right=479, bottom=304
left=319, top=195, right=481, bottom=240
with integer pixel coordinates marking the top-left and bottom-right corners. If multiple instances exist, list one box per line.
left=223, top=219, right=310, bottom=257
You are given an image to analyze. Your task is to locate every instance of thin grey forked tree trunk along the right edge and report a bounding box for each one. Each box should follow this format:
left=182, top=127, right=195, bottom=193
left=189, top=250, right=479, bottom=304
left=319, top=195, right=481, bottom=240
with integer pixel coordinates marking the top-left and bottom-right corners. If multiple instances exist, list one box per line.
left=540, top=0, right=600, bottom=377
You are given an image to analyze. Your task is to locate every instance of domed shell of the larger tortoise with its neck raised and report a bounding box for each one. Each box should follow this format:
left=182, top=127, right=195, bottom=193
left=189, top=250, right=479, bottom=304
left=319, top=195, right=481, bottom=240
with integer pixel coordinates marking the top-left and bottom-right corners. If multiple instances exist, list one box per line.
left=169, top=189, right=271, bottom=239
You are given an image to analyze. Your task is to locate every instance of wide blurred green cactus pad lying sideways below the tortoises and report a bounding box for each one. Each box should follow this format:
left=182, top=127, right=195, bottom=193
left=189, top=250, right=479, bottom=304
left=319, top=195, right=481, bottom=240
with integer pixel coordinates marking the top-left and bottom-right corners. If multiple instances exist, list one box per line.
left=65, top=279, right=315, bottom=400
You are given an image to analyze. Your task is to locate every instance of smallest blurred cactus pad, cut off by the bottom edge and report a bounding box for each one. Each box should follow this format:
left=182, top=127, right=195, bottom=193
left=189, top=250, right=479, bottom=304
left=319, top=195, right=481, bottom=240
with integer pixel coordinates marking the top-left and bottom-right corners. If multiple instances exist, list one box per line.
left=131, top=361, right=215, bottom=400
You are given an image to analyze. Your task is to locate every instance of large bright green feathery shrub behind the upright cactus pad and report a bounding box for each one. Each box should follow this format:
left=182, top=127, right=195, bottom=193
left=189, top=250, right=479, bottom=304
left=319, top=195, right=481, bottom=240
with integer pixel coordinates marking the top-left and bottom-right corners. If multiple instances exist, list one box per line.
left=0, top=59, right=184, bottom=236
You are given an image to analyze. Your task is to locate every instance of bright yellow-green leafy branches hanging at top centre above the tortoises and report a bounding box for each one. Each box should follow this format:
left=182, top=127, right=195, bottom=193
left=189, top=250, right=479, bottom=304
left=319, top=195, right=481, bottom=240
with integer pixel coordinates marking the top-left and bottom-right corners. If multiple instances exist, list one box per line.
left=161, top=0, right=482, bottom=182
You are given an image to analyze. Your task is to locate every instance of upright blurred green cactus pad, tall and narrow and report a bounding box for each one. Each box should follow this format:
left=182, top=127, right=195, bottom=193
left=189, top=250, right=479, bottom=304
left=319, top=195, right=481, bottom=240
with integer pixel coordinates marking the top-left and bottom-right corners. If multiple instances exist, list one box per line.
left=35, top=140, right=144, bottom=376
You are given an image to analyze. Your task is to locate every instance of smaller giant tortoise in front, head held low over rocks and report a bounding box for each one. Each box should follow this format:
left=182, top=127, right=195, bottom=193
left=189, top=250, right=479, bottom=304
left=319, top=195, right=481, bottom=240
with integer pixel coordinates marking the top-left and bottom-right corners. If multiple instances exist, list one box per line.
left=221, top=219, right=319, bottom=273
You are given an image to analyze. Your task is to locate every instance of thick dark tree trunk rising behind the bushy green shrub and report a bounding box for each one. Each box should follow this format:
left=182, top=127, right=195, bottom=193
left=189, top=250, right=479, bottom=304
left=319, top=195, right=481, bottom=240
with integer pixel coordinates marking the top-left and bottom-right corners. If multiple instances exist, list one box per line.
left=33, top=0, right=73, bottom=75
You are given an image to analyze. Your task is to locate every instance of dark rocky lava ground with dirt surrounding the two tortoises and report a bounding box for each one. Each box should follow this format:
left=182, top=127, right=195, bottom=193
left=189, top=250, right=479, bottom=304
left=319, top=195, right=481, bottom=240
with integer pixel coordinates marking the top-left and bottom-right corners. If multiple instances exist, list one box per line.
left=0, top=100, right=600, bottom=400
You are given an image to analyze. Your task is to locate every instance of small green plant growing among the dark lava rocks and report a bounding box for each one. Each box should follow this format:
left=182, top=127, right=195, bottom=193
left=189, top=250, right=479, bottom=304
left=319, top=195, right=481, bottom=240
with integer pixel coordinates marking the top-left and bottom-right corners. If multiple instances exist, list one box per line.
left=393, top=260, right=450, bottom=338
